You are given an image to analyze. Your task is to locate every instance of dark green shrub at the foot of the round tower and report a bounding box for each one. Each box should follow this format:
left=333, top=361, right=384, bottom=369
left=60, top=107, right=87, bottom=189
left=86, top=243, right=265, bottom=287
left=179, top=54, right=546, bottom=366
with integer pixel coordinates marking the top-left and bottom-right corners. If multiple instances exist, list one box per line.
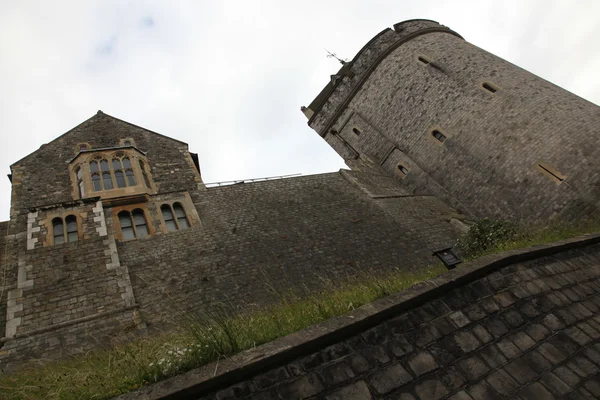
left=457, top=218, right=524, bottom=259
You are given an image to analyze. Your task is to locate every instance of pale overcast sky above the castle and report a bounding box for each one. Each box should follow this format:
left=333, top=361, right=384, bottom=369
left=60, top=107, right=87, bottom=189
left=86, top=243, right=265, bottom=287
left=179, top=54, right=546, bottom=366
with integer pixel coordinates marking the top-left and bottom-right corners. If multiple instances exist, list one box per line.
left=0, top=0, right=600, bottom=220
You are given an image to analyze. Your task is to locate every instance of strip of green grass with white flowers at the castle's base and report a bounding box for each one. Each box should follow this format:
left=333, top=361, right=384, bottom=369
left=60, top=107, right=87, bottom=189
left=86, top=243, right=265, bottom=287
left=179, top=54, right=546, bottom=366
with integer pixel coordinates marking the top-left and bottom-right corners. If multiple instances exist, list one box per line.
left=0, top=265, right=445, bottom=400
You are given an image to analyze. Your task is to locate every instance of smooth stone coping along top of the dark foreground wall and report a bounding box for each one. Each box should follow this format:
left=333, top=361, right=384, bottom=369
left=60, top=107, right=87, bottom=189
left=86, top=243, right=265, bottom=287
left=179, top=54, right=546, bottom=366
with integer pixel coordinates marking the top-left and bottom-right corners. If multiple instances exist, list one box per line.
left=115, top=234, right=600, bottom=400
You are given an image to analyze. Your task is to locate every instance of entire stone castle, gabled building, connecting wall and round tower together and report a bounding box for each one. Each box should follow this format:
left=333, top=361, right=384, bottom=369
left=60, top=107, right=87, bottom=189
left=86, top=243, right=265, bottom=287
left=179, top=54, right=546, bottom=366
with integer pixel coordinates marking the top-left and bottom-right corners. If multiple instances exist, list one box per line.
left=0, top=20, right=600, bottom=376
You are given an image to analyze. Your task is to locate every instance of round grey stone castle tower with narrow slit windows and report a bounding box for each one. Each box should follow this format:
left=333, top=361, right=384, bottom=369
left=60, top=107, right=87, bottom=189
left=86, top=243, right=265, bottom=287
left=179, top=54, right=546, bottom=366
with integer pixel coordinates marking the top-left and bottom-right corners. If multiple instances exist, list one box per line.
left=302, top=20, right=600, bottom=220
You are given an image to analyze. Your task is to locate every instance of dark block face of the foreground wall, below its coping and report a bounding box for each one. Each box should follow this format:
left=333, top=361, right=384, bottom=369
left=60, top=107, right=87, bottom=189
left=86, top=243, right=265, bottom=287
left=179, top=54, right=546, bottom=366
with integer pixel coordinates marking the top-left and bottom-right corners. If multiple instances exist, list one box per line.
left=185, top=244, right=600, bottom=400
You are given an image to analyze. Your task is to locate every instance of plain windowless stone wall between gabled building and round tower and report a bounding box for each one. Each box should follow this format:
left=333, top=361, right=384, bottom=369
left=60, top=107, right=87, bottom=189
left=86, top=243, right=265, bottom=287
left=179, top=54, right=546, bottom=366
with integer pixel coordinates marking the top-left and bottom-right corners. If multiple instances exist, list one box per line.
left=117, top=173, right=460, bottom=328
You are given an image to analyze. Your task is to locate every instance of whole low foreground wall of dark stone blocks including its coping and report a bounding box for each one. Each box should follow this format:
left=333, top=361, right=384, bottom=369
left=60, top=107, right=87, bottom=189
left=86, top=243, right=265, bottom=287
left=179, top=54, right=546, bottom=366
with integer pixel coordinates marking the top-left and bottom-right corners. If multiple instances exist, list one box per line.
left=121, top=236, right=600, bottom=400
